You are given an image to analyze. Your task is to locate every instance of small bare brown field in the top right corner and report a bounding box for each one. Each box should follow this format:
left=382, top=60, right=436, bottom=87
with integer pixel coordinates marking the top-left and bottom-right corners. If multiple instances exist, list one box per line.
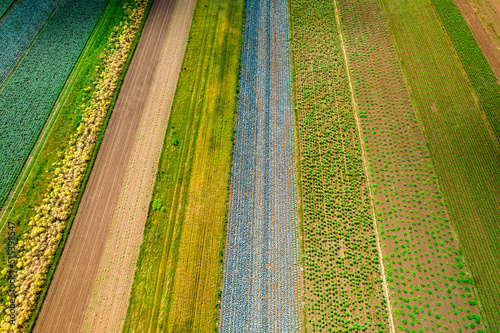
left=455, top=0, right=500, bottom=82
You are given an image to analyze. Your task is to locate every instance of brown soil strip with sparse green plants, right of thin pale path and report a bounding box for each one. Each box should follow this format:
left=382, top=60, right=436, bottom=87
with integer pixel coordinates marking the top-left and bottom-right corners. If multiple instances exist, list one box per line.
left=337, top=0, right=484, bottom=332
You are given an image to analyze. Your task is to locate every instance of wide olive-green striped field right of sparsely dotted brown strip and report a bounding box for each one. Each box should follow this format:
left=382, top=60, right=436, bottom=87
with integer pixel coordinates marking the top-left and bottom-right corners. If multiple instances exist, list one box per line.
left=376, top=0, right=500, bottom=331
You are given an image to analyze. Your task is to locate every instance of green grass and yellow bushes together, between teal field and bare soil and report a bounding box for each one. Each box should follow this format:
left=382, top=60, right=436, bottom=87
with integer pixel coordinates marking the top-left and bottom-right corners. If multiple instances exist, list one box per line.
left=1, top=0, right=147, bottom=332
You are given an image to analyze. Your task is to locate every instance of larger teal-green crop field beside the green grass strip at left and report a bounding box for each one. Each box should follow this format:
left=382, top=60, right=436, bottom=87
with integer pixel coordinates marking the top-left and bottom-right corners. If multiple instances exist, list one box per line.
left=0, top=0, right=107, bottom=206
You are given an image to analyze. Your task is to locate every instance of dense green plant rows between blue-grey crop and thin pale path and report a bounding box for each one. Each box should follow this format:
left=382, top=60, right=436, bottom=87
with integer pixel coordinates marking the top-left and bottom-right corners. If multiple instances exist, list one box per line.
left=290, top=0, right=391, bottom=333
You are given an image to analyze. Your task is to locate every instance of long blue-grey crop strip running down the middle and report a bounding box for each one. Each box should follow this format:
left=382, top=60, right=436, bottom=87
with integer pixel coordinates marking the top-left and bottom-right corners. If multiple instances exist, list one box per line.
left=220, top=0, right=301, bottom=332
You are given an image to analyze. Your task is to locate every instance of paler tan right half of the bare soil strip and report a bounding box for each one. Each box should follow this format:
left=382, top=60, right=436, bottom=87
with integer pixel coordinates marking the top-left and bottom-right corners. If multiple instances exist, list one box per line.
left=79, top=1, right=196, bottom=332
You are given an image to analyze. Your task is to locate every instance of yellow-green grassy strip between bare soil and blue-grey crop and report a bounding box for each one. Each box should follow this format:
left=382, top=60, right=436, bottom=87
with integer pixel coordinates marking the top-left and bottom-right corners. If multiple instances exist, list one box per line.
left=124, top=0, right=245, bottom=332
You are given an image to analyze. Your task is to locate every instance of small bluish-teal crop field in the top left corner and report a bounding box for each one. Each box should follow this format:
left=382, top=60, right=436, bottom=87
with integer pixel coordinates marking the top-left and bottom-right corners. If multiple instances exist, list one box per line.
left=0, top=0, right=61, bottom=87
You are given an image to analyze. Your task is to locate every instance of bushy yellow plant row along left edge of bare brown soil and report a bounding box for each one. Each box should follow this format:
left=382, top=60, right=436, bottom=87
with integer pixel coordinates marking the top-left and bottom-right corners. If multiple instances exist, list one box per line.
left=0, top=0, right=148, bottom=332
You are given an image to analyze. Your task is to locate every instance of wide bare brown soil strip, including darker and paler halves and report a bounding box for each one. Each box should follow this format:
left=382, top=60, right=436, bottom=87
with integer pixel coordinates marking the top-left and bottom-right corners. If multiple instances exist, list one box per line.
left=34, top=0, right=196, bottom=333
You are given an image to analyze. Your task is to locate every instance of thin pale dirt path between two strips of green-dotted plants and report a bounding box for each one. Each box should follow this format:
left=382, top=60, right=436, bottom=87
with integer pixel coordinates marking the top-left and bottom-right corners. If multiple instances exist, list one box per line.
left=333, top=0, right=396, bottom=333
